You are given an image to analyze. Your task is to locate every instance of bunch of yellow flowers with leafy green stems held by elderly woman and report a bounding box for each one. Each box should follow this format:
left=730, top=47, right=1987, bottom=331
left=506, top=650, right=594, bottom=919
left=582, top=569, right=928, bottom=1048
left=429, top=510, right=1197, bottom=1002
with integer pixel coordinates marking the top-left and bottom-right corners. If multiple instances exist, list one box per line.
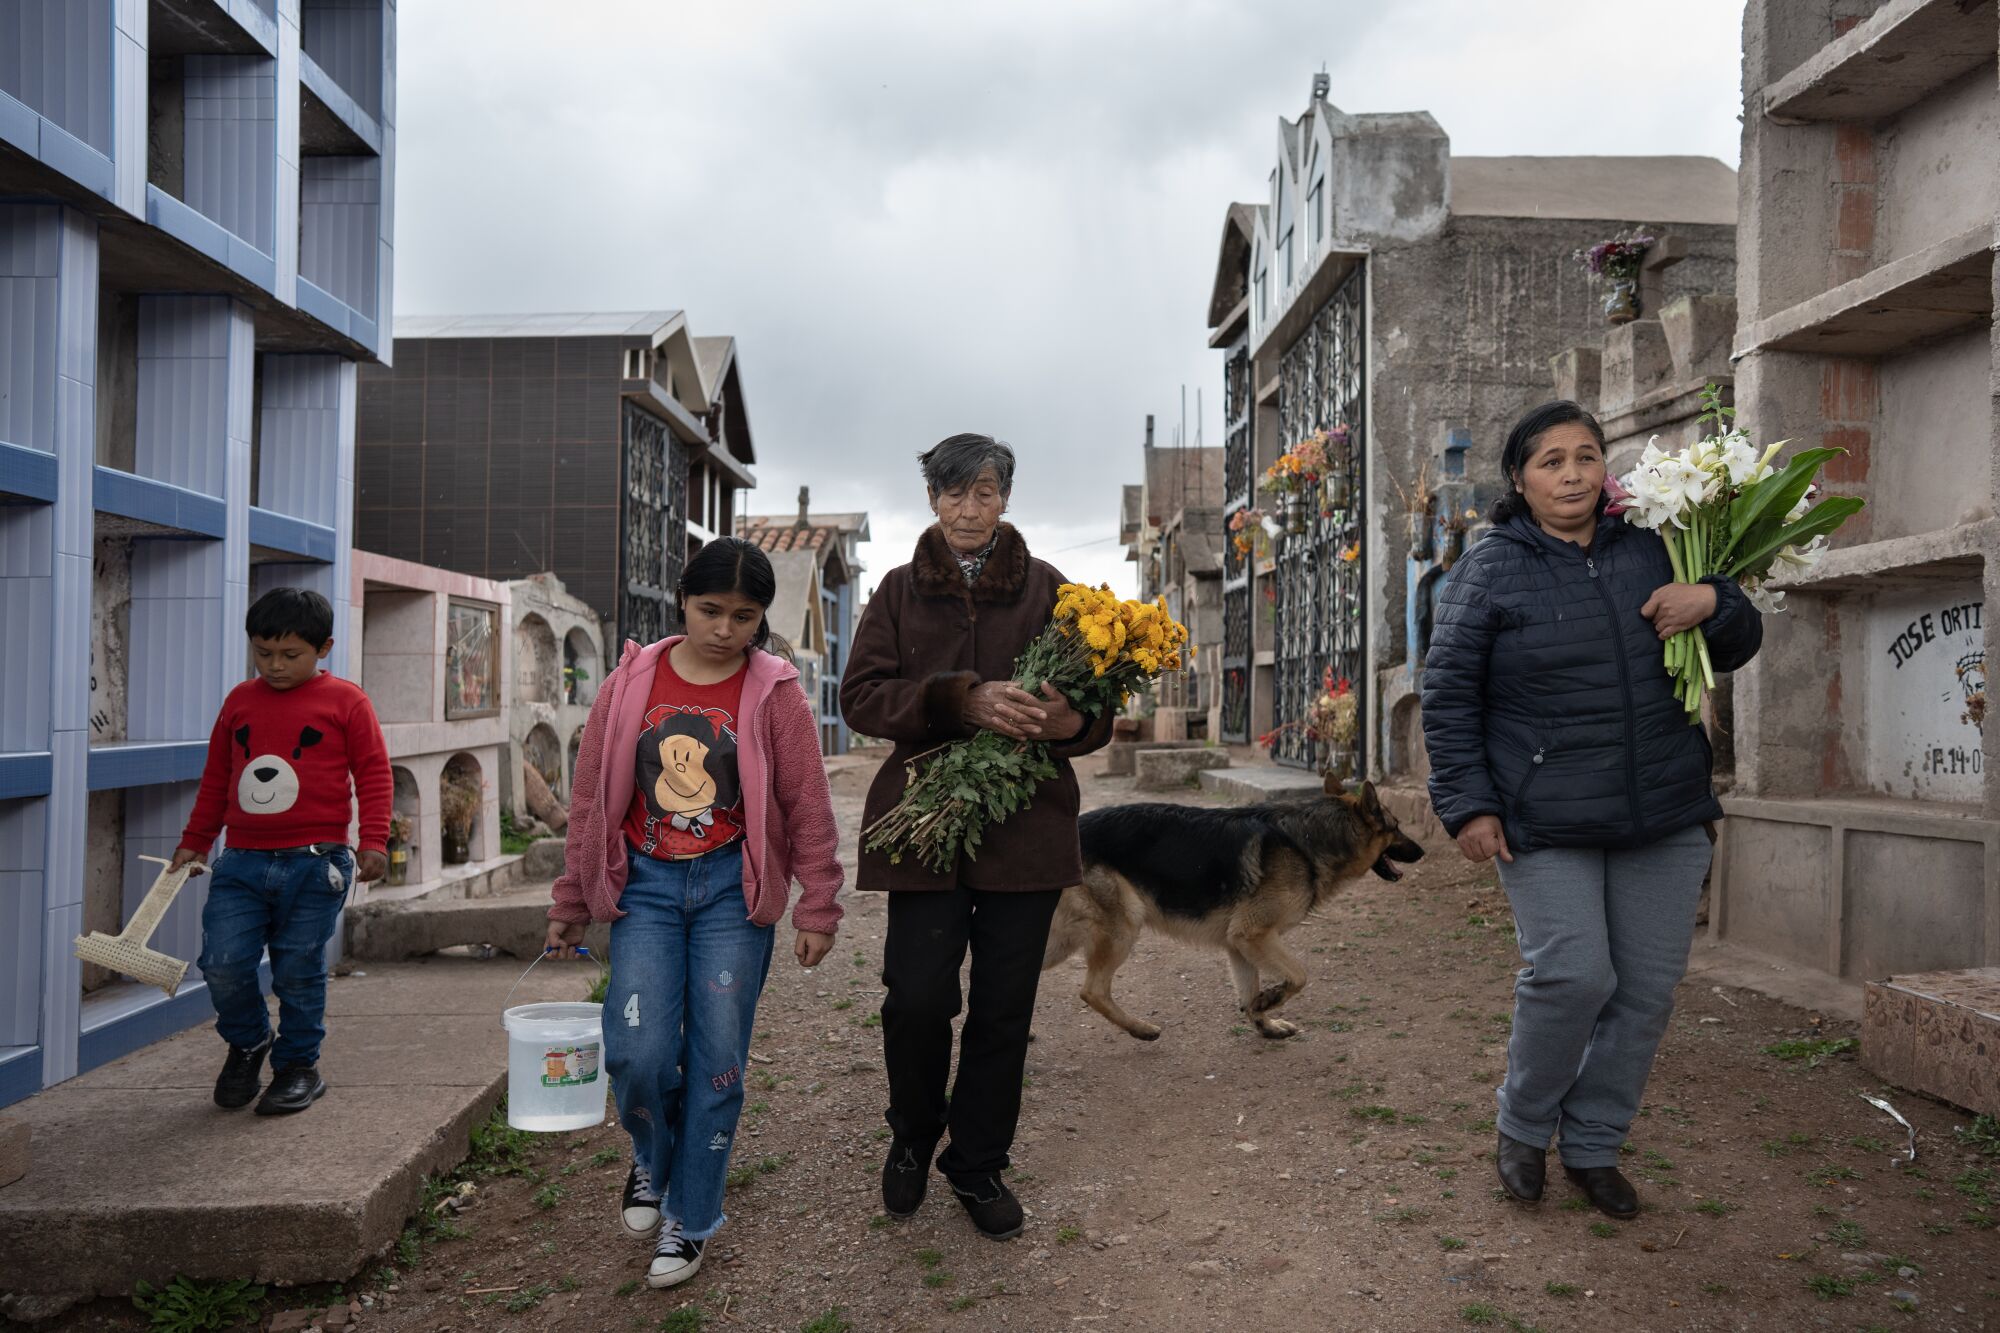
left=862, top=582, right=1194, bottom=871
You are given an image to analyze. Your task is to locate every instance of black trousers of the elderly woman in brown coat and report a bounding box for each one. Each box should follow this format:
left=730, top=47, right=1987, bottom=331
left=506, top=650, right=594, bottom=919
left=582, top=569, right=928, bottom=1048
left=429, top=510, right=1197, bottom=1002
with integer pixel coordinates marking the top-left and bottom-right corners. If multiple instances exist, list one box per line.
left=882, top=889, right=1062, bottom=1177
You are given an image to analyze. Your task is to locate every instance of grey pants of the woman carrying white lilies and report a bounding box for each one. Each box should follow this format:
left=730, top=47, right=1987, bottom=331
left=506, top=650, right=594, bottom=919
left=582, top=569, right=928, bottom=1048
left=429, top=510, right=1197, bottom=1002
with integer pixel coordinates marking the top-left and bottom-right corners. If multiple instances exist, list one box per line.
left=1496, top=825, right=1712, bottom=1167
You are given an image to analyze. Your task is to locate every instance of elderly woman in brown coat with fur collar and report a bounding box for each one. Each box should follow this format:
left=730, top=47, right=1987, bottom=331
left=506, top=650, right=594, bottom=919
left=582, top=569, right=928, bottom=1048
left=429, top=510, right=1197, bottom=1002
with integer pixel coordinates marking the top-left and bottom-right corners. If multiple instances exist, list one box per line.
left=840, top=434, right=1112, bottom=1241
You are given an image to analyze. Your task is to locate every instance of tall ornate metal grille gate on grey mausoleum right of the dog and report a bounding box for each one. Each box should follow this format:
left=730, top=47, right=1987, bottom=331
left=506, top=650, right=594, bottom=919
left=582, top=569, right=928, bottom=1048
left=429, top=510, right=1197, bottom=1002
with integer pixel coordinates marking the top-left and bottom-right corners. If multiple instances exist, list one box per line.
left=1272, top=266, right=1368, bottom=775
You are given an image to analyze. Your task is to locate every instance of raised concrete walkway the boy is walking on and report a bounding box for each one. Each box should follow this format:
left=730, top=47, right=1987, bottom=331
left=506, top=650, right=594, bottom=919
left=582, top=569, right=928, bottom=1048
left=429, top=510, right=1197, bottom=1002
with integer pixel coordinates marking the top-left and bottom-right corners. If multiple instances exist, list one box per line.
left=0, top=959, right=596, bottom=1317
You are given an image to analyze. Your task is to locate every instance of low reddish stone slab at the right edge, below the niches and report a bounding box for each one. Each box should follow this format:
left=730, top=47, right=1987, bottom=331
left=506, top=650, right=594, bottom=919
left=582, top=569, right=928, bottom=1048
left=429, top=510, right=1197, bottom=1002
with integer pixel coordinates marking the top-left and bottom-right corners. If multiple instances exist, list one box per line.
left=1862, top=967, right=2000, bottom=1115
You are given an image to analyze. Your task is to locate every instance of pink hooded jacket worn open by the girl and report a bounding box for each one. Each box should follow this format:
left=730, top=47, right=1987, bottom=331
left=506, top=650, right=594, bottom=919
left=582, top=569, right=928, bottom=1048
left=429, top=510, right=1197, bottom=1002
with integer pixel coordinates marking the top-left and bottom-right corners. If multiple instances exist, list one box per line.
left=548, top=634, right=842, bottom=935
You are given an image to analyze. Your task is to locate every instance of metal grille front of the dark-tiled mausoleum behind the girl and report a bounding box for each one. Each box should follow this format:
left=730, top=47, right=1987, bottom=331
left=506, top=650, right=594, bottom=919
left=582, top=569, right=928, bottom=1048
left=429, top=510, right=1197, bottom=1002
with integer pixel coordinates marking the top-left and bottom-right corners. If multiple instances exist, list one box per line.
left=618, top=404, right=688, bottom=642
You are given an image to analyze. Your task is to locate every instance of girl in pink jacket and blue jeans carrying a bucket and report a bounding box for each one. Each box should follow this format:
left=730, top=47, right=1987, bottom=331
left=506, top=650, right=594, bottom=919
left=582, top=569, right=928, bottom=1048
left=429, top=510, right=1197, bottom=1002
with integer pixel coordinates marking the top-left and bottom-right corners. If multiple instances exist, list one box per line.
left=548, top=536, right=842, bottom=1287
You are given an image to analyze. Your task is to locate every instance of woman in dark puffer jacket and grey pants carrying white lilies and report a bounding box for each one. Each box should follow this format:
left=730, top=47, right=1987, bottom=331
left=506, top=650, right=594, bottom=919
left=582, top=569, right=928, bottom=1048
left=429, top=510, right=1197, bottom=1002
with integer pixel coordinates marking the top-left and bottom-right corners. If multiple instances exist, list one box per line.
left=1424, top=402, right=1764, bottom=1217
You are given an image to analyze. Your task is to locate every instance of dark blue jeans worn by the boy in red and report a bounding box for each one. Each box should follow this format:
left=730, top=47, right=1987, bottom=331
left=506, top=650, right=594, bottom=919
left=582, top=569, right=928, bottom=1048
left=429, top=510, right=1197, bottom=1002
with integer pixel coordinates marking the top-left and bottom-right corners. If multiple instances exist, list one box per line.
left=200, top=843, right=354, bottom=1069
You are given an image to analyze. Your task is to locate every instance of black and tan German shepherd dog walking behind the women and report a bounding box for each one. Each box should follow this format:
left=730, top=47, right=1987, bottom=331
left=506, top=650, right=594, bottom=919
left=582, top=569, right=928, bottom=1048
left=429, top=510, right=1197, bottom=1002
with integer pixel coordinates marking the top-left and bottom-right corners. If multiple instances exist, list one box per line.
left=1042, top=779, right=1424, bottom=1041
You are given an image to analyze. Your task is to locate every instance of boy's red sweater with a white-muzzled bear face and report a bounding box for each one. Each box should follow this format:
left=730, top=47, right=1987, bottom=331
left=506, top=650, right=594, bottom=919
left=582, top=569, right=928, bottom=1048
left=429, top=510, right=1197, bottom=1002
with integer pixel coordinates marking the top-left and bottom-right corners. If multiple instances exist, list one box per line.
left=180, top=673, right=396, bottom=857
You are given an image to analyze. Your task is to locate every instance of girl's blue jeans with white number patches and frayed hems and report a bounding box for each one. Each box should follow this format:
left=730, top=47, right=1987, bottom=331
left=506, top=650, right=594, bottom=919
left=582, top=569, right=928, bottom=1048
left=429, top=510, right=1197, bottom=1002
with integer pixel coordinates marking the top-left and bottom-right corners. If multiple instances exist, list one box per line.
left=604, top=843, right=778, bottom=1241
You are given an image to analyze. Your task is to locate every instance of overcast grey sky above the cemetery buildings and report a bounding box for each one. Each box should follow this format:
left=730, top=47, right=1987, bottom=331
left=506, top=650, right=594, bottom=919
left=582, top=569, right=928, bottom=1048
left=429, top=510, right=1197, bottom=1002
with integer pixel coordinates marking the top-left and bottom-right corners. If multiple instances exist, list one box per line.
left=396, top=0, right=1742, bottom=590
